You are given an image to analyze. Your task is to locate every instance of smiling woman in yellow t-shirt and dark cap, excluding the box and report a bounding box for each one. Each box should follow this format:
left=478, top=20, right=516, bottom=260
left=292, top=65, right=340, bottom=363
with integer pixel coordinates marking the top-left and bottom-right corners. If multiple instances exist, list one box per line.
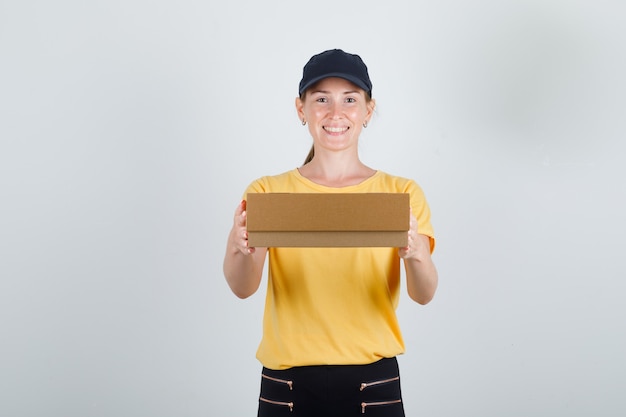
left=224, top=49, right=438, bottom=417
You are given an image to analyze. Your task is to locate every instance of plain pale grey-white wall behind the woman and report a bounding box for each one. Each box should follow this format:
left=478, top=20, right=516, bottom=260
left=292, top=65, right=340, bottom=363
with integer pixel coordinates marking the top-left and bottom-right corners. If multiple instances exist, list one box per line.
left=0, top=0, right=626, bottom=417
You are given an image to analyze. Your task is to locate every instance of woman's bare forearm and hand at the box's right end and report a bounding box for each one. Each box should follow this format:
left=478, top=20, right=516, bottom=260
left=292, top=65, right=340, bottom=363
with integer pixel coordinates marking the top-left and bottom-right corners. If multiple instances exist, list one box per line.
left=398, top=214, right=439, bottom=304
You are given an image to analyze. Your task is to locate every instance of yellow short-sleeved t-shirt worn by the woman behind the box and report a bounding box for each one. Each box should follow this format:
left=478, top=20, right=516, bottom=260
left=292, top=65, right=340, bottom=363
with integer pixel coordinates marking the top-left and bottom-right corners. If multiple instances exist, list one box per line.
left=246, top=169, right=435, bottom=369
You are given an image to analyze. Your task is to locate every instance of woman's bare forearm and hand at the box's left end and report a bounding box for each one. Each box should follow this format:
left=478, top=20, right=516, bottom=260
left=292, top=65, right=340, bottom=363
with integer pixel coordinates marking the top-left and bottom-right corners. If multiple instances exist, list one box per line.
left=224, top=200, right=267, bottom=298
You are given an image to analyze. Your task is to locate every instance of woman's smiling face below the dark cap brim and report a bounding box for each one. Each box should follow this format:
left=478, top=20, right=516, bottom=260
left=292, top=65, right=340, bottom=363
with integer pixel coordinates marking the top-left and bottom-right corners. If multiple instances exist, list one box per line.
left=296, top=78, right=374, bottom=155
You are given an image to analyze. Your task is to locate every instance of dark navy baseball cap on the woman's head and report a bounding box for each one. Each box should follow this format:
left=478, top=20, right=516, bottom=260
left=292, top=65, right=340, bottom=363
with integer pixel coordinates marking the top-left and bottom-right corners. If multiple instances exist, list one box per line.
left=298, top=49, right=372, bottom=97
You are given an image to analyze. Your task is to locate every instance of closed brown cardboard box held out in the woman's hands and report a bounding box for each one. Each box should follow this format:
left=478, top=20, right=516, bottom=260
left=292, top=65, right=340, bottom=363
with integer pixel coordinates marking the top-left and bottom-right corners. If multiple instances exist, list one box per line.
left=246, top=193, right=410, bottom=247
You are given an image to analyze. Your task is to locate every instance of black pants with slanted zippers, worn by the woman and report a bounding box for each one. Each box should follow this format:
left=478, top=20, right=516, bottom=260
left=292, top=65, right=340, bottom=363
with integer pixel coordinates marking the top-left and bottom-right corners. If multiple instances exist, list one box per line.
left=258, top=358, right=404, bottom=417
